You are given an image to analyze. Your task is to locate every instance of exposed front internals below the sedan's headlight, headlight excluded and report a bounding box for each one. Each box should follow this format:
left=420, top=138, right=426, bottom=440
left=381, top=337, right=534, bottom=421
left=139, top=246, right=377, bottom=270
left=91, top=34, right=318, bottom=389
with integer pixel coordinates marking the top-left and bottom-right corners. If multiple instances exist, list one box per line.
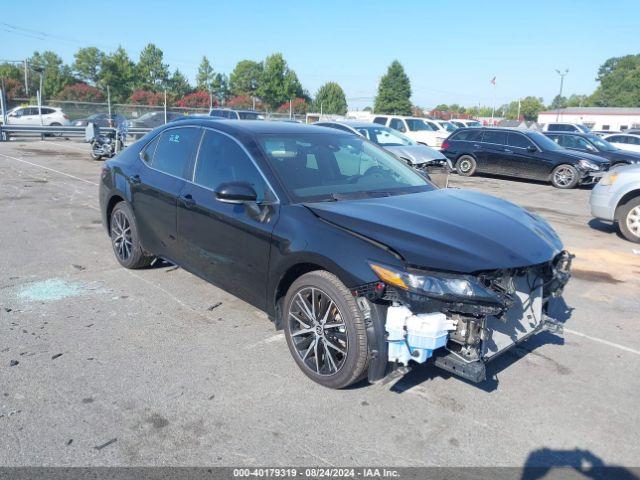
left=354, top=251, right=572, bottom=382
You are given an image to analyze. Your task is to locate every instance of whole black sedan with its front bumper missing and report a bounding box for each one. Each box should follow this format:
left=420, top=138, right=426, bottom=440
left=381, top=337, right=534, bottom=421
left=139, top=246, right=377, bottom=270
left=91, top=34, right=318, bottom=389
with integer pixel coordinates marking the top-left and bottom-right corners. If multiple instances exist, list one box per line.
left=100, top=119, right=570, bottom=388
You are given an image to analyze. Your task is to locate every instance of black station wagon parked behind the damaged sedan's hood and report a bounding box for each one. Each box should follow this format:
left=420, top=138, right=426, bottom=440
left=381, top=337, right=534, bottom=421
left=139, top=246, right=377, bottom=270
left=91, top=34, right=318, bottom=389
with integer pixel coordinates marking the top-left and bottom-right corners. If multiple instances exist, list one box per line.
left=441, top=127, right=609, bottom=188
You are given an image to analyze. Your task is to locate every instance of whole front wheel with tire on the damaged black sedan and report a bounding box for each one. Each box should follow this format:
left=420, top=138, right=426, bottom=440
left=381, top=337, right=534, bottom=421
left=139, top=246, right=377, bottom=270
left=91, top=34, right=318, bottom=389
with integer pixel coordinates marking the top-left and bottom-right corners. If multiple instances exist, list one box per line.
left=283, top=270, right=369, bottom=388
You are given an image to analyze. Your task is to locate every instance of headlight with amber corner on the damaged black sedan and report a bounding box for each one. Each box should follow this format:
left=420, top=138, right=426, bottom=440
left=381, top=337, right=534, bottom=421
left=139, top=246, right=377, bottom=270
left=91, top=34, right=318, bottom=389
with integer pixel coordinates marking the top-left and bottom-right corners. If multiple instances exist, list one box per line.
left=369, top=263, right=501, bottom=303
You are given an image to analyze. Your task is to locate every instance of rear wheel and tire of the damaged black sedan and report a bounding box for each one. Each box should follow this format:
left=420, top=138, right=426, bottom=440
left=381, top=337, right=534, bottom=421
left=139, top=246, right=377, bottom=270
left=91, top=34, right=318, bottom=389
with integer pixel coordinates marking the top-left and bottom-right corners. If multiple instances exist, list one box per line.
left=109, top=202, right=154, bottom=269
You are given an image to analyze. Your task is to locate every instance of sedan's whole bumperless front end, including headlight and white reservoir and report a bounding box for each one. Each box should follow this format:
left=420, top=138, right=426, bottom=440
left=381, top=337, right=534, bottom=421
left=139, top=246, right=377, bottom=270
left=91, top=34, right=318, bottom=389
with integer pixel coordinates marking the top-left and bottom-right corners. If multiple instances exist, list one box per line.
left=353, top=251, right=572, bottom=382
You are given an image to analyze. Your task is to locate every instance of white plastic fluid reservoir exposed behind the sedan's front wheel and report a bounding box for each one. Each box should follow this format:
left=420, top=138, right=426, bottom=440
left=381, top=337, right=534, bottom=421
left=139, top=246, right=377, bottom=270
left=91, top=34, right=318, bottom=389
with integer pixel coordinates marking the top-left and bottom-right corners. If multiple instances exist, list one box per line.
left=385, top=306, right=455, bottom=365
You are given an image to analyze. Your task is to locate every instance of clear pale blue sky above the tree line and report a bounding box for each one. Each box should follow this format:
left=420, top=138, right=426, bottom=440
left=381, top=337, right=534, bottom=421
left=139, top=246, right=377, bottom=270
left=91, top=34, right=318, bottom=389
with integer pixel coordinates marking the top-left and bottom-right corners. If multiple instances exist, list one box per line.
left=0, top=0, right=640, bottom=109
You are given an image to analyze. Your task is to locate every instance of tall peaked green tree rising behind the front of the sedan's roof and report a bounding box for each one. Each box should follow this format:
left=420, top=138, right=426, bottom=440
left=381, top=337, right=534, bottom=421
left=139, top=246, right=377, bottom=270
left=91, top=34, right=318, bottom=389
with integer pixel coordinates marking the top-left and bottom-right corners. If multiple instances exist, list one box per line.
left=258, top=53, right=308, bottom=109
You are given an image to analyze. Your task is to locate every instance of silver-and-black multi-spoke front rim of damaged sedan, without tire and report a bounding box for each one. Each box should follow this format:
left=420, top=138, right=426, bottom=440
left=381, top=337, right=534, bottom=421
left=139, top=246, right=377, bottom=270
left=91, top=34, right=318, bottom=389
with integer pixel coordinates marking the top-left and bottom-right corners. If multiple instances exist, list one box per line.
left=287, top=287, right=349, bottom=376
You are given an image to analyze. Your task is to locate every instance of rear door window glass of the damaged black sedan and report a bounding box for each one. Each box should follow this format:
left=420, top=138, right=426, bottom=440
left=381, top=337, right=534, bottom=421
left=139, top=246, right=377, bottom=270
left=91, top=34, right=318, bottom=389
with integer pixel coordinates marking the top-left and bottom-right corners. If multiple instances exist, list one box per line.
left=151, top=127, right=202, bottom=179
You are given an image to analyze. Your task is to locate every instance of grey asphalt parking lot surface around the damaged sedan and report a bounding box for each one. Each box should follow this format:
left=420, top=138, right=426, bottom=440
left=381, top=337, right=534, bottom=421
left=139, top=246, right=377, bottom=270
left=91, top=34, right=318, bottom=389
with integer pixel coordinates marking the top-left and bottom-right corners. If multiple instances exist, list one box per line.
left=0, top=140, right=640, bottom=466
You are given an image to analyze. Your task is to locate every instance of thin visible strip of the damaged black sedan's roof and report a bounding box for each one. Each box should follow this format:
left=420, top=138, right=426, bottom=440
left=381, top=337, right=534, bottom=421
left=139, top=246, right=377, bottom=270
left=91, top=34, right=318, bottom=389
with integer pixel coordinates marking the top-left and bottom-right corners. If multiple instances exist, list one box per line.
left=171, top=117, right=342, bottom=135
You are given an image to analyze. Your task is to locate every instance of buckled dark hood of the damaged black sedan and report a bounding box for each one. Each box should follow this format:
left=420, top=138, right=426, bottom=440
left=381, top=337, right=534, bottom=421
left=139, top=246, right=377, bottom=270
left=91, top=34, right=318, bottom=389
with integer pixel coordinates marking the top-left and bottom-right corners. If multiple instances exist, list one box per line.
left=305, top=189, right=562, bottom=273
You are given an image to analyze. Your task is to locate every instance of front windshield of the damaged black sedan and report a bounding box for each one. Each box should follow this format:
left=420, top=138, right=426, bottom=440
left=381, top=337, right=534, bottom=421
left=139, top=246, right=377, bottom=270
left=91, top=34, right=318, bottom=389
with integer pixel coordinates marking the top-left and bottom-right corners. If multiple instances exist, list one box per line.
left=257, top=133, right=435, bottom=202
